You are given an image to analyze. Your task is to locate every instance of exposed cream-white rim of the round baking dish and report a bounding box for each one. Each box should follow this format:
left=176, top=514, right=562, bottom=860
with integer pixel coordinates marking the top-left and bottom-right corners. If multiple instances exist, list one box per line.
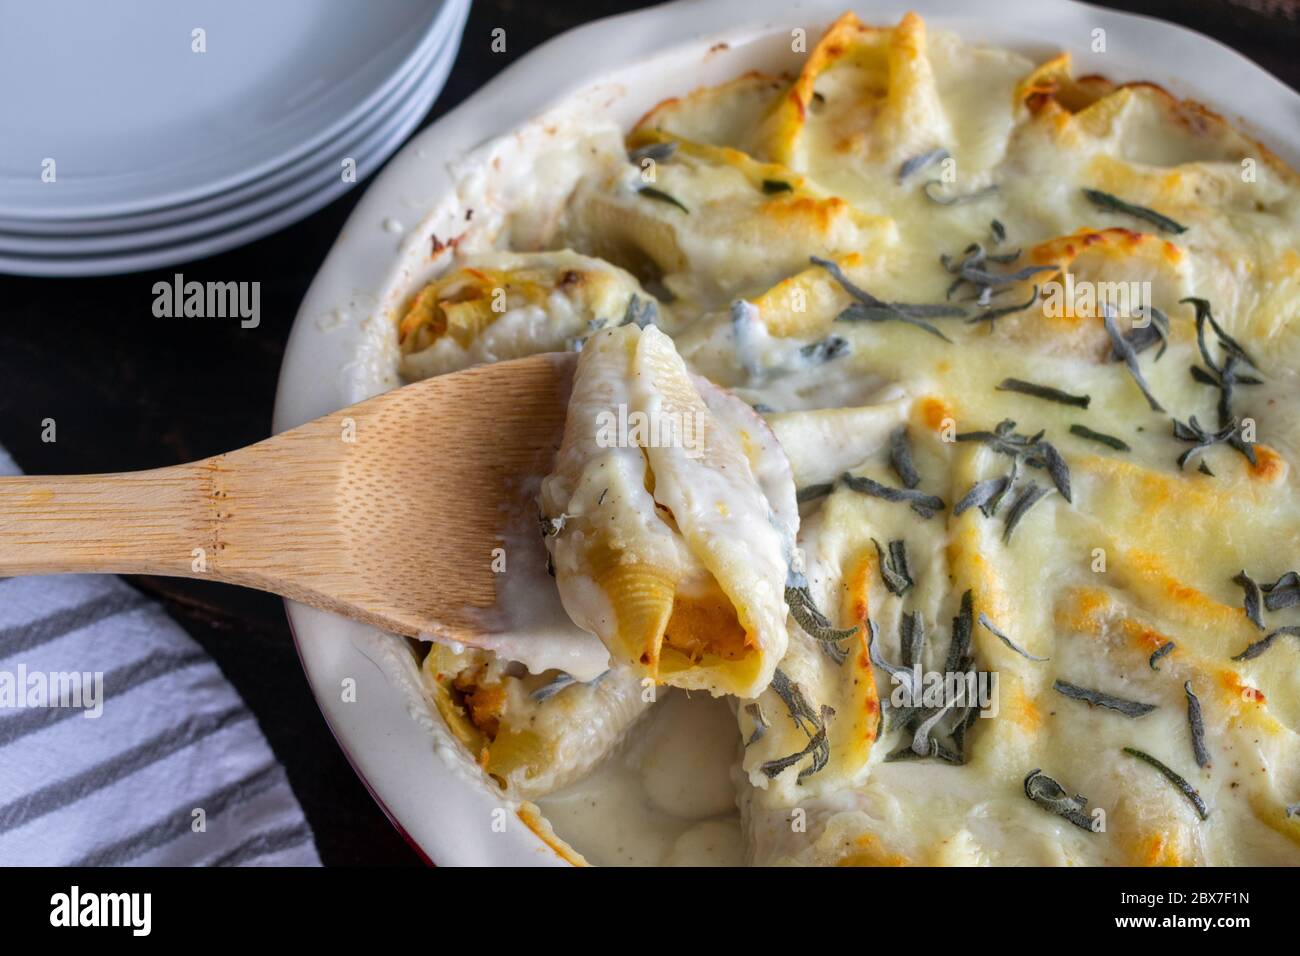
left=274, top=0, right=1300, bottom=865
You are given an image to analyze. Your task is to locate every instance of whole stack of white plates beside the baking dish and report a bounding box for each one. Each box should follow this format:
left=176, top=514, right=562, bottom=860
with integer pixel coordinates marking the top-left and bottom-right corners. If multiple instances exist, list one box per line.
left=0, top=0, right=469, bottom=276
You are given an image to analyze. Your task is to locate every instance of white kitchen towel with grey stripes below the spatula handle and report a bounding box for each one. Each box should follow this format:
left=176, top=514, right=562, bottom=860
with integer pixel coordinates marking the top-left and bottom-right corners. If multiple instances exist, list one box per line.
left=0, top=450, right=320, bottom=866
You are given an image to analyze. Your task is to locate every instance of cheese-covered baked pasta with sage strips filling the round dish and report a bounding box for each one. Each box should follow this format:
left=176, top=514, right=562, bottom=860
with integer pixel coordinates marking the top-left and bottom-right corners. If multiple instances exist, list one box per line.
left=392, top=14, right=1300, bottom=865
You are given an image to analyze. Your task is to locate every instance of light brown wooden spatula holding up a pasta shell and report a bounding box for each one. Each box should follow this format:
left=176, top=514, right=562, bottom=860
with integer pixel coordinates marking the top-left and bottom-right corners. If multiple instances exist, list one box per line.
left=0, top=354, right=576, bottom=643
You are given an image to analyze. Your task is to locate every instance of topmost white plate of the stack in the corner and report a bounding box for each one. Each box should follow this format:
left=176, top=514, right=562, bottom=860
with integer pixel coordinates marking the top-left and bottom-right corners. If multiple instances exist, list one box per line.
left=0, top=0, right=449, bottom=219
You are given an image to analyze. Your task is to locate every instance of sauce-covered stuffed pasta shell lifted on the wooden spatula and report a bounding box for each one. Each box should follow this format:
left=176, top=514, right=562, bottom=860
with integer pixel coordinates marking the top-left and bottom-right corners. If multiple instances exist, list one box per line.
left=541, top=325, right=796, bottom=697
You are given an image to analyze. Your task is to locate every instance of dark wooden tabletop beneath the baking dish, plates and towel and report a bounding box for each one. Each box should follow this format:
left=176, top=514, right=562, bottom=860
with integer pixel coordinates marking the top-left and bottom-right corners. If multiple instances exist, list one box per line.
left=0, top=0, right=1300, bottom=864
